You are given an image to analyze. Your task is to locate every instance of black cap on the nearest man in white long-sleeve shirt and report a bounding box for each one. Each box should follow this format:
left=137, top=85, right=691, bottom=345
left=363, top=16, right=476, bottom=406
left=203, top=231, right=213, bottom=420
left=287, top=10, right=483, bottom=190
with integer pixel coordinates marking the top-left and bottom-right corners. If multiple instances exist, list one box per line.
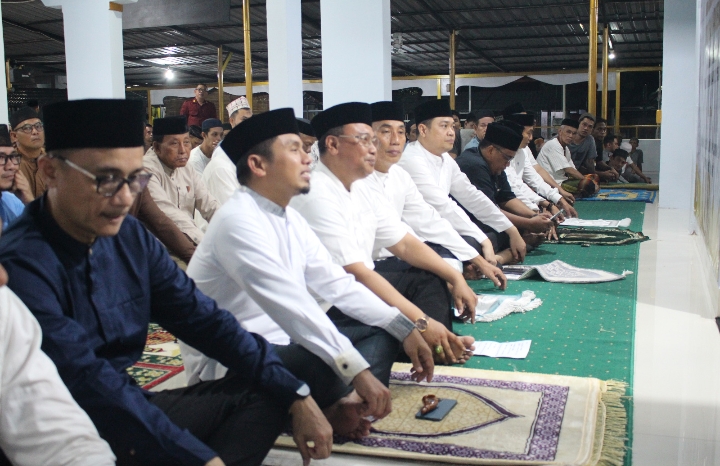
left=220, top=108, right=299, bottom=164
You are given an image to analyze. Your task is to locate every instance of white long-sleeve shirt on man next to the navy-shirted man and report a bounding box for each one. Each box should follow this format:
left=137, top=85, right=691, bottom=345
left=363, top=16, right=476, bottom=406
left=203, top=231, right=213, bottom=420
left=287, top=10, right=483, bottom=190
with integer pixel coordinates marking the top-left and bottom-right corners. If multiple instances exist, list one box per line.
left=182, top=188, right=414, bottom=383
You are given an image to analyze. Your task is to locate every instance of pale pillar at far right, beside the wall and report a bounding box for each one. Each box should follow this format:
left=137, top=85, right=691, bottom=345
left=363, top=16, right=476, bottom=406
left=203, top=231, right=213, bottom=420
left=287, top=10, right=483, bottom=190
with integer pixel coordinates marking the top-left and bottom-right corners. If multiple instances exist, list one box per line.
left=660, top=0, right=698, bottom=210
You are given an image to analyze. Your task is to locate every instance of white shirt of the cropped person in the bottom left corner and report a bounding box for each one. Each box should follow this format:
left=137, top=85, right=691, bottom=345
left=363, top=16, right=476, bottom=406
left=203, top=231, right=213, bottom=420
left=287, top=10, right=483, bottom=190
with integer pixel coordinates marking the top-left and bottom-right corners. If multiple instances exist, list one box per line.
left=0, top=286, right=115, bottom=466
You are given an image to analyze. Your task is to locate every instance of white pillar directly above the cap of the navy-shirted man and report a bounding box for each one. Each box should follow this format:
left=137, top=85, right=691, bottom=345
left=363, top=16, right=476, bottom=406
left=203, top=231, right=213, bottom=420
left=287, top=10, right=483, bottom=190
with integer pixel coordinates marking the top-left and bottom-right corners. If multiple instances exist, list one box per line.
left=43, top=0, right=137, bottom=100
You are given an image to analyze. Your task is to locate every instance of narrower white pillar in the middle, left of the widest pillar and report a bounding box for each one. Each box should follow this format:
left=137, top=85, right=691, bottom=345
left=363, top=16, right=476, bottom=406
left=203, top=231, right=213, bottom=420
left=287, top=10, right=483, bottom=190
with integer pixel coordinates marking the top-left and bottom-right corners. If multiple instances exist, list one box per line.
left=265, top=0, right=306, bottom=114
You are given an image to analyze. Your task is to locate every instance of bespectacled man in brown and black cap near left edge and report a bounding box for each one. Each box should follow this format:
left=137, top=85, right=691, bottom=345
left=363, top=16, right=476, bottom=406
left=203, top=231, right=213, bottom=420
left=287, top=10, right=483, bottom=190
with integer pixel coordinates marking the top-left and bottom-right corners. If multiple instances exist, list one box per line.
left=10, top=107, right=45, bottom=198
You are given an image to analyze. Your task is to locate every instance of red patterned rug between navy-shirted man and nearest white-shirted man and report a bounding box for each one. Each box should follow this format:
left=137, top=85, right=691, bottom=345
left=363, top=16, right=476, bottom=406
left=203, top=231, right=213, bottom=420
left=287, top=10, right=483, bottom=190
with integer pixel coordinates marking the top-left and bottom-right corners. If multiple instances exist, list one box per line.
left=127, top=324, right=185, bottom=390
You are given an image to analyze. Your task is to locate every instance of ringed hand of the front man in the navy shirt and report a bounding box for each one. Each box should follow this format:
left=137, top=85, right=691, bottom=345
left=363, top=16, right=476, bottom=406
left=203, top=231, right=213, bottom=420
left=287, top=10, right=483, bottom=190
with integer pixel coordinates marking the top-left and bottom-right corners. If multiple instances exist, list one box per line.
left=290, top=396, right=332, bottom=466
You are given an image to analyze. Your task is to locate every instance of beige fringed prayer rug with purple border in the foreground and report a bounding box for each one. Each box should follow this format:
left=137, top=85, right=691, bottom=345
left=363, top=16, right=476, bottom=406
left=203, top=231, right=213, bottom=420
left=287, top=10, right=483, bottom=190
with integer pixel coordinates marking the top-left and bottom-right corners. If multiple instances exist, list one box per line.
left=276, top=364, right=627, bottom=466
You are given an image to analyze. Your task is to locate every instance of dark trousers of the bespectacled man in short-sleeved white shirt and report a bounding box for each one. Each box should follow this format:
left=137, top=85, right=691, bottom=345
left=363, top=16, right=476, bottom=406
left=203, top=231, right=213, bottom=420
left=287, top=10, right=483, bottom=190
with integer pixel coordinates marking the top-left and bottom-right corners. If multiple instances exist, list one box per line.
left=375, top=257, right=452, bottom=331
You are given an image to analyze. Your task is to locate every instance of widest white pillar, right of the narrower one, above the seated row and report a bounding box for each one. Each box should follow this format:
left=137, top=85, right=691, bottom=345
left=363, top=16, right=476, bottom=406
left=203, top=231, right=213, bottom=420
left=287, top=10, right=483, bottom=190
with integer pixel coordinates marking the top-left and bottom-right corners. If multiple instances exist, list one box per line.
left=320, top=0, right=392, bottom=108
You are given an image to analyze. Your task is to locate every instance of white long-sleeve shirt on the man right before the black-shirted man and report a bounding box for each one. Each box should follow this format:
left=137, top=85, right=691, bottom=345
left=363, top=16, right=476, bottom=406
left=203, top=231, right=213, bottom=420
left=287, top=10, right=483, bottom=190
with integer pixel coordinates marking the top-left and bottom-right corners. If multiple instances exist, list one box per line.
left=398, top=141, right=513, bottom=237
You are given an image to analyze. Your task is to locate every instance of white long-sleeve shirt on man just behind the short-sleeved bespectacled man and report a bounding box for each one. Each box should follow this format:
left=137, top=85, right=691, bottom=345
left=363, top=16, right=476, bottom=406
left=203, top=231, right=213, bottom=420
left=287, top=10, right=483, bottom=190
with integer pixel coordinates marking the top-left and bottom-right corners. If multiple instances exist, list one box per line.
left=365, top=165, right=478, bottom=261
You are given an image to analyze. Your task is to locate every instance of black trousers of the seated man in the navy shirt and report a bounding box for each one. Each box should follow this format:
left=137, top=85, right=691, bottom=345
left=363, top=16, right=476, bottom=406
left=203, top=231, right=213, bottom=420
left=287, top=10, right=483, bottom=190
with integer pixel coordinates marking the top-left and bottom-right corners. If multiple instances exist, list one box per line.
left=148, top=374, right=288, bottom=466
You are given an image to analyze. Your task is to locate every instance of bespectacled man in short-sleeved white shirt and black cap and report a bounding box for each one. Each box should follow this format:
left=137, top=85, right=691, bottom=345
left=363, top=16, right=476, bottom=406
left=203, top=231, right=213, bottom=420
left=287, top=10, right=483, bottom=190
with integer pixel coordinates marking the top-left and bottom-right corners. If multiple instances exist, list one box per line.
left=291, top=102, right=477, bottom=363
